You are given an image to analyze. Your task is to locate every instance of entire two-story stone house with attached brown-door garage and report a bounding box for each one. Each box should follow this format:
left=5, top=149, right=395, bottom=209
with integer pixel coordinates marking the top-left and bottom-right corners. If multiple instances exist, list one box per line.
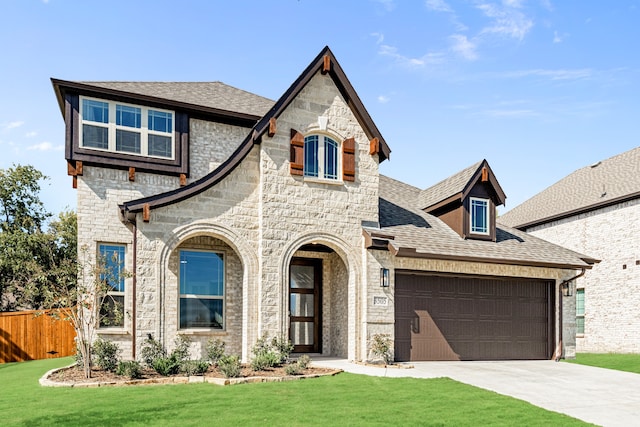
left=53, top=48, right=593, bottom=361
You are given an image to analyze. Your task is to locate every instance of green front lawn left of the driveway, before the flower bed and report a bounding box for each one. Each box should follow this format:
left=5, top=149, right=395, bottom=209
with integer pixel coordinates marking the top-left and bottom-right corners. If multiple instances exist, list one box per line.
left=0, top=358, right=585, bottom=426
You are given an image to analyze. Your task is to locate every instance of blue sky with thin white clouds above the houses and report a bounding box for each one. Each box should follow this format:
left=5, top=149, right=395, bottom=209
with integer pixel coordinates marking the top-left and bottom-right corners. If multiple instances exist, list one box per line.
left=0, top=0, right=640, bottom=217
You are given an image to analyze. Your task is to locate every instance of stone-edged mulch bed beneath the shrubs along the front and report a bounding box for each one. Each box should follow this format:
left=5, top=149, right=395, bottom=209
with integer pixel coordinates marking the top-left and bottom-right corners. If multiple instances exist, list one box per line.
left=40, top=365, right=341, bottom=387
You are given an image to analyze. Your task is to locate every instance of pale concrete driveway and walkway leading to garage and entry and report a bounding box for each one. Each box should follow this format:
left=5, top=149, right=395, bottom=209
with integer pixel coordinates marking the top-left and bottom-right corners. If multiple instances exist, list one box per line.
left=313, top=357, right=640, bottom=427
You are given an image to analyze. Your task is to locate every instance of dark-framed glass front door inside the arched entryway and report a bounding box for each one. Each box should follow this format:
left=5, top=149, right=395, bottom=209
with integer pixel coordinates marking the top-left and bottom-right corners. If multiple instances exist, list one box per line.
left=289, top=258, right=322, bottom=353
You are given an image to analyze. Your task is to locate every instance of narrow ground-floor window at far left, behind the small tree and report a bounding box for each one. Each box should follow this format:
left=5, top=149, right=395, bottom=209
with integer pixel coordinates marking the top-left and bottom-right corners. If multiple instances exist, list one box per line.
left=98, top=243, right=126, bottom=328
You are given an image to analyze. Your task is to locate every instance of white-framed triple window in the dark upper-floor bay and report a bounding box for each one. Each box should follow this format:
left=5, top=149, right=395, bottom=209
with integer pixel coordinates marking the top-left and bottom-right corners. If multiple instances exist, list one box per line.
left=80, top=96, right=175, bottom=159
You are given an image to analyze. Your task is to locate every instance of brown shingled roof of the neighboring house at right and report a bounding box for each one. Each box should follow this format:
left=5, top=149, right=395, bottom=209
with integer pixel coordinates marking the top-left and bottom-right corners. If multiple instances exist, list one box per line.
left=499, top=147, right=640, bottom=229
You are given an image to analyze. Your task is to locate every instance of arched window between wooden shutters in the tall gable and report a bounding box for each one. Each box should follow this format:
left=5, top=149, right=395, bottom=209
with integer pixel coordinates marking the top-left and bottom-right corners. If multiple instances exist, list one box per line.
left=304, top=134, right=341, bottom=181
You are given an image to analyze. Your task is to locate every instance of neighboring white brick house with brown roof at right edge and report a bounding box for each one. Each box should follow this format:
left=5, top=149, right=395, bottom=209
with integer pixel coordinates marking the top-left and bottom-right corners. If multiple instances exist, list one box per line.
left=500, top=147, right=640, bottom=353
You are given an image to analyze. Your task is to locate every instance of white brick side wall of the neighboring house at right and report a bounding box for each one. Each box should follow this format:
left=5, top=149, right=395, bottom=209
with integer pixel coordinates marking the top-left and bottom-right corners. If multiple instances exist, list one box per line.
left=527, top=199, right=640, bottom=353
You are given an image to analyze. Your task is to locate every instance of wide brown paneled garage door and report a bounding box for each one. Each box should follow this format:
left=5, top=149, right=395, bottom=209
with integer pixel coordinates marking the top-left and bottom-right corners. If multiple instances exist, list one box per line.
left=395, top=272, right=554, bottom=361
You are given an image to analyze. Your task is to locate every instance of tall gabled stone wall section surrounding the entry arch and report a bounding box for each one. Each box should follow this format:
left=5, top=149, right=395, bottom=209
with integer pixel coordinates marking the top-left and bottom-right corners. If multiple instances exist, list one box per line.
left=258, top=73, right=378, bottom=359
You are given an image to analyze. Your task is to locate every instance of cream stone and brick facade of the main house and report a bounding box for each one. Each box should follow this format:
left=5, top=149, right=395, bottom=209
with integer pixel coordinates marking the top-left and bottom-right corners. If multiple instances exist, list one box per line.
left=67, top=50, right=575, bottom=361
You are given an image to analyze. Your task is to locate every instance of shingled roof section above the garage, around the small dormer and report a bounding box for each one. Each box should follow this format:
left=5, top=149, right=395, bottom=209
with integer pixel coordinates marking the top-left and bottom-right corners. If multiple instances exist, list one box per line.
left=365, top=175, right=596, bottom=268
